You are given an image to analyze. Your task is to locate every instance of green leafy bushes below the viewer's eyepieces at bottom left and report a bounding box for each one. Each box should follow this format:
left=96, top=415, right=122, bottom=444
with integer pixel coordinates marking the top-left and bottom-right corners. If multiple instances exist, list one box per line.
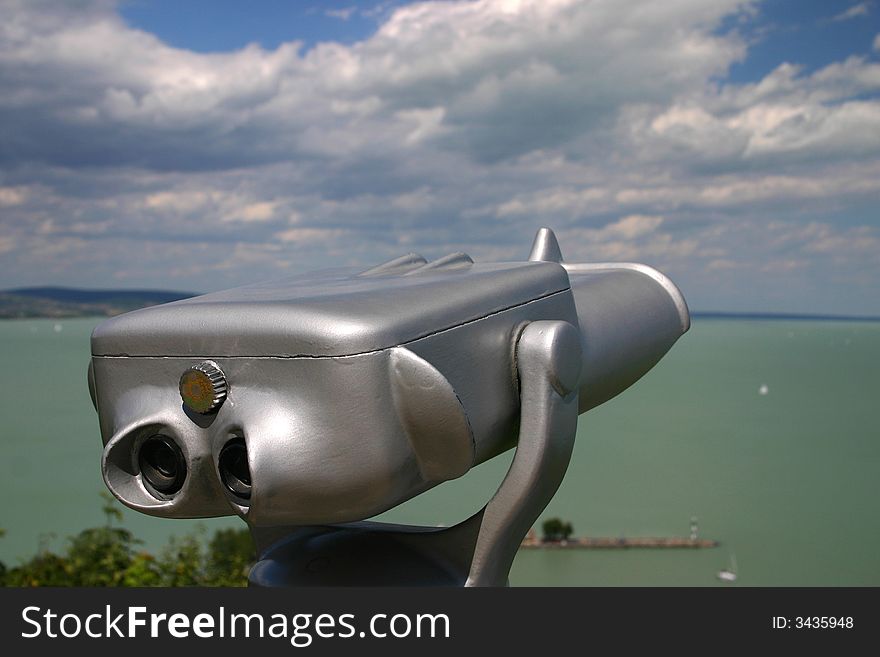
left=0, top=494, right=256, bottom=586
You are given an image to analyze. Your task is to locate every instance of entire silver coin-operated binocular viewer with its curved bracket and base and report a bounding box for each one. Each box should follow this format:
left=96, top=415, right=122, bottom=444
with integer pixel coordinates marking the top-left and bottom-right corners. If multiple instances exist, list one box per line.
left=89, top=228, right=689, bottom=586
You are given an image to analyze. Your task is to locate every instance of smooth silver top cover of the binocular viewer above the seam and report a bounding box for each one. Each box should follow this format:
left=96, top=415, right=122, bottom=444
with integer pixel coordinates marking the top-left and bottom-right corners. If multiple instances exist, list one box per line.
left=92, top=254, right=569, bottom=358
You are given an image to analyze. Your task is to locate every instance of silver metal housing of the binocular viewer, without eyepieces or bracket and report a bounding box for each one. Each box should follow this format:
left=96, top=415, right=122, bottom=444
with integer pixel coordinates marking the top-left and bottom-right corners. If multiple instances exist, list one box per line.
left=90, top=229, right=689, bottom=527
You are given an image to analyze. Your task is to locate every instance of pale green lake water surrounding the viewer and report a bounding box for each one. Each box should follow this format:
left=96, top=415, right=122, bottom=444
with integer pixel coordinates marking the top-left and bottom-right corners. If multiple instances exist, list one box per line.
left=0, top=319, right=880, bottom=586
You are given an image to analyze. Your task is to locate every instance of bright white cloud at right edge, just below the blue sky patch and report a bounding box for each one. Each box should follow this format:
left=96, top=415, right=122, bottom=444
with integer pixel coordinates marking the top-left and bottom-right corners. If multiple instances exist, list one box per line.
left=633, top=57, right=880, bottom=164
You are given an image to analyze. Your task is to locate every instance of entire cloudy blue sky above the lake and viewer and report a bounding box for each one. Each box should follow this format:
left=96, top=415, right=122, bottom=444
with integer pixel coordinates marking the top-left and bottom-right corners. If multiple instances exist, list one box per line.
left=0, top=0, right=880, bottom=315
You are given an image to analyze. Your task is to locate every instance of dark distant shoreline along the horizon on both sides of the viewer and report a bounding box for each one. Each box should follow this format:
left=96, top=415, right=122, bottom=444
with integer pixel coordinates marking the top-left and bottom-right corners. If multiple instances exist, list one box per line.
left=0, top=287, right=880, bottom=322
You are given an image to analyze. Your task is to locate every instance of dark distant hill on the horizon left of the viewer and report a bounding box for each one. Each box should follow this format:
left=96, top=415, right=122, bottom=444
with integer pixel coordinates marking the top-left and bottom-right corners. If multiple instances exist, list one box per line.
left=0, top=287, right=197, bottom=319
